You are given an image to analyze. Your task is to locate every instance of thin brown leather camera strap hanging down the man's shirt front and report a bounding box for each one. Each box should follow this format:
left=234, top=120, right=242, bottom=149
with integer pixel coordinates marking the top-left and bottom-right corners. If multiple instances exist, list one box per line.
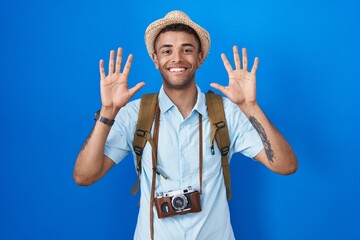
left=150, top=109, right=203, bottom=240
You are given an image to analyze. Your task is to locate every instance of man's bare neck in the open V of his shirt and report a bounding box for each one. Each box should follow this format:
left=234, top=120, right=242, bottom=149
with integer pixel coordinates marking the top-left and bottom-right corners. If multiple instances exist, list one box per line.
left=164, top=84, right=197, bottom=119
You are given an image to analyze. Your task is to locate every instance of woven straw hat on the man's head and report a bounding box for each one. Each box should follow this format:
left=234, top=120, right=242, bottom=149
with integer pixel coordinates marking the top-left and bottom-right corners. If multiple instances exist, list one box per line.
left=145, top=10, right=210, bottom=60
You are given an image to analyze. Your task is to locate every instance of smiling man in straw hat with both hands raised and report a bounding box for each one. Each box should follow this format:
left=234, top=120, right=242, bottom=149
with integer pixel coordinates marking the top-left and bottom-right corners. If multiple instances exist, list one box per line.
left=74, top=11, right=297, bottom=240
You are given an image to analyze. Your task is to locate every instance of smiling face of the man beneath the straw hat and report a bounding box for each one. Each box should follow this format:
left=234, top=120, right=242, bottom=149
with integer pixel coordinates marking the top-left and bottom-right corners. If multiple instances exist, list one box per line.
left=152, top=31, right=203, bottom=89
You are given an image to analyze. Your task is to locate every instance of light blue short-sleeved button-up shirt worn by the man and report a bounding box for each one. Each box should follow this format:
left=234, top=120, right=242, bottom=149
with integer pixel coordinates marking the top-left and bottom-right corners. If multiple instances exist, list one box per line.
left=105, top=85, right=263, bottom=240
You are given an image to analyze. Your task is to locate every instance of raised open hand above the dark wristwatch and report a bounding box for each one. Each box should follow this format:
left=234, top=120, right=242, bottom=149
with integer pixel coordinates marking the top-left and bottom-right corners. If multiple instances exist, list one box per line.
left=99, top=48, right=145, bottom=114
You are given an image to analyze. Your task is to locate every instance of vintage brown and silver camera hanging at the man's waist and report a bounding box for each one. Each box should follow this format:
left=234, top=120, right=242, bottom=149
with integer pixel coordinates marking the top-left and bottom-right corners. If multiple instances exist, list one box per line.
left=154, top=187, right=201, bottom=218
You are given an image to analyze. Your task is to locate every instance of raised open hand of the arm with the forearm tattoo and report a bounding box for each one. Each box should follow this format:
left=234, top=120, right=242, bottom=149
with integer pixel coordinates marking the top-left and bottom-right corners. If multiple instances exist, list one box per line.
left=210, top=46, right=259, bottom=105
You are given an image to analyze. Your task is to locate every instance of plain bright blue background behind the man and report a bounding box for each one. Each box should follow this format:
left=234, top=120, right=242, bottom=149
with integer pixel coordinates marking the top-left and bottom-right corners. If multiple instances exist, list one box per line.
left=0, top=0, right=360, bottom=240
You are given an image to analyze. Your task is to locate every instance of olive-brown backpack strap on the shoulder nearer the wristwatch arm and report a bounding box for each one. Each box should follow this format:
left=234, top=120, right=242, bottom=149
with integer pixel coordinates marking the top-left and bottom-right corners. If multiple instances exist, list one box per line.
left=131, top=93, right=158, bottom=195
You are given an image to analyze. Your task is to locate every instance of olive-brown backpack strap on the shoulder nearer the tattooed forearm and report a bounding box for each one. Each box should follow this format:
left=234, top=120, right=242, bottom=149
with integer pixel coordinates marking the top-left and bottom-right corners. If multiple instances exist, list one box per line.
left=206, top=91, right=231, bottom=200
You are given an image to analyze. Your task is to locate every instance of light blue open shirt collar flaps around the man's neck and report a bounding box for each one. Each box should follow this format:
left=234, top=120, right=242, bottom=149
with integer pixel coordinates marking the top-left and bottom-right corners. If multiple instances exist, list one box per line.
left=159, top=86, right=207, bottom=117
